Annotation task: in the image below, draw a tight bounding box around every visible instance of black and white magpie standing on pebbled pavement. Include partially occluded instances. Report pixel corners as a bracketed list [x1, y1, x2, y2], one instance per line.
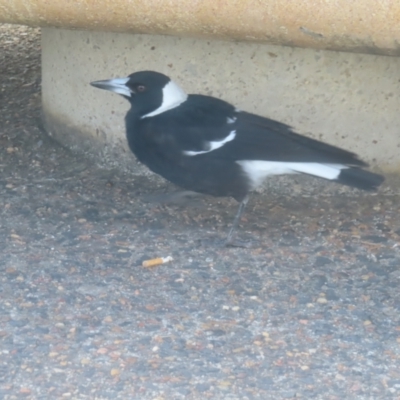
[90, 71, 384, 246]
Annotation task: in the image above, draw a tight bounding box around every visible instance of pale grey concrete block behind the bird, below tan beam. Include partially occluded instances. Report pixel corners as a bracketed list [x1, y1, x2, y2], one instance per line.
[42, 28, 400, 173]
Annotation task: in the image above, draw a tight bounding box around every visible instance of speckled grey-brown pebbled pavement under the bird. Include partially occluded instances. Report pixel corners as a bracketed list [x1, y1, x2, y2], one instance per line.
[0, 25, 400, 400]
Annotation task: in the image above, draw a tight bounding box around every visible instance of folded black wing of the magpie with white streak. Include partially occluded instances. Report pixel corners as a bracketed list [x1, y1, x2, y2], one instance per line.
[142, 95, 366, 167]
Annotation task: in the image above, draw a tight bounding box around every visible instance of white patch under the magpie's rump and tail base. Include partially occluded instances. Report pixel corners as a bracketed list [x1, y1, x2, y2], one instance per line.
[236, 160, 348, 189]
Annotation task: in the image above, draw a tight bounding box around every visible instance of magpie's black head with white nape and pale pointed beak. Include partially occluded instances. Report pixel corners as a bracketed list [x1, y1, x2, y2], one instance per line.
[90, 71, 187, 118]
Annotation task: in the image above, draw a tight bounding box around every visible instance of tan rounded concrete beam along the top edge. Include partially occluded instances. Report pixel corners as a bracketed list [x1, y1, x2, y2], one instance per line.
[0, 0, 400, 55]
